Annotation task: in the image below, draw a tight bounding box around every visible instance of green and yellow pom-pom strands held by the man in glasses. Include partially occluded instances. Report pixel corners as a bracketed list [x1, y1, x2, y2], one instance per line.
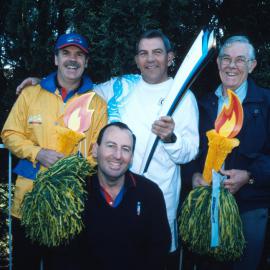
[179, 187, 245, 261]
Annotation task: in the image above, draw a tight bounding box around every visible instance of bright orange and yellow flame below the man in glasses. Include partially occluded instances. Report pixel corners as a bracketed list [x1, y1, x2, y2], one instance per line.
[215, 89, 243, 138]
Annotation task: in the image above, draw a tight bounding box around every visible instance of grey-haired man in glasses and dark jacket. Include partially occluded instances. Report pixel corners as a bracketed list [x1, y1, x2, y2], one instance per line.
[184, 36, 270, 270]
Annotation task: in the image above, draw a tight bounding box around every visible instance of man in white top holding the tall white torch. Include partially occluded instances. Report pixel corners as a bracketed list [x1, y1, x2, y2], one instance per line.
[15, 30, 199, 269]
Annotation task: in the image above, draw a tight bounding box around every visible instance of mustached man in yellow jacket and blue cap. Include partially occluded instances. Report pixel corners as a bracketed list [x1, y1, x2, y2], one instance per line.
[1, 33, 107, 269]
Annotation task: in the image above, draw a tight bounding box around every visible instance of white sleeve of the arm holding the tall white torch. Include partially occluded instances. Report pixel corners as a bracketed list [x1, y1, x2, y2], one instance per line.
[163, 91, 199, 164]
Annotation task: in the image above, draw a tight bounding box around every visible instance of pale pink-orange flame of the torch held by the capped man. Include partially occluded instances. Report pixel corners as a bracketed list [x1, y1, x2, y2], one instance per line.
[64, 92, 95, 132]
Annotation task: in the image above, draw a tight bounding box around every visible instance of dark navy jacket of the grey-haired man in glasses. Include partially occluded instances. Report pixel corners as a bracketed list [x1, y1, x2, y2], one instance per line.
[182, 79, 270, 211]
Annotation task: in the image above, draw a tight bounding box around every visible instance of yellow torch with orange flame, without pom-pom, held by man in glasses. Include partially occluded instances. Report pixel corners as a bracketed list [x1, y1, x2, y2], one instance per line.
[203, 90, 243, 184]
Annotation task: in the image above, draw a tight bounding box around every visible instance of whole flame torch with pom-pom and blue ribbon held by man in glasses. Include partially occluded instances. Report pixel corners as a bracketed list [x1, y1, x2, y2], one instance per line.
[179, 90, 245, 261]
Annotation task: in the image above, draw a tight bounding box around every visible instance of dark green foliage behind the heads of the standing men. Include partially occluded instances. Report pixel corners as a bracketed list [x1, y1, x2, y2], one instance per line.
[0, 0, 270, 99]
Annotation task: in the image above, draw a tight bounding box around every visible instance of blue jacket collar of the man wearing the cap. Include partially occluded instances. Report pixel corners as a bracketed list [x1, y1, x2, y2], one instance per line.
[40, 72, 93, 94]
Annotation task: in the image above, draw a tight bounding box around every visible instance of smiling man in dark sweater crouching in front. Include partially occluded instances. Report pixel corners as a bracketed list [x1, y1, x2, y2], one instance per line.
[80, 122, 171, 270]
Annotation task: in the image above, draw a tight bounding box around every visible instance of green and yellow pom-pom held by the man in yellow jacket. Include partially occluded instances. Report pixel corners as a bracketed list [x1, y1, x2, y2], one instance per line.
[21, 155, 94, 246]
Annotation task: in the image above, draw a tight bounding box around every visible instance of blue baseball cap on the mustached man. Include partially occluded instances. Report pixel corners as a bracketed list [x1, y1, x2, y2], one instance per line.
[54, 33, 89, 54]
